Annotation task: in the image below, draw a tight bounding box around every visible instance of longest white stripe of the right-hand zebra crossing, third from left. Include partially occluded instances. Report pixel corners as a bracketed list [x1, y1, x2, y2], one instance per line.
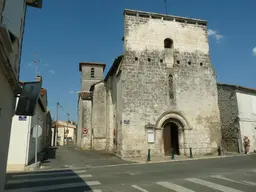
[185, 178, 243, 192]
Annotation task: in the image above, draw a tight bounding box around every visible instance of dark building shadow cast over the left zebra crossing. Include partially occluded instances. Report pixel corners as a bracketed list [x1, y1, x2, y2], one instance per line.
[5, 169, 94, 192]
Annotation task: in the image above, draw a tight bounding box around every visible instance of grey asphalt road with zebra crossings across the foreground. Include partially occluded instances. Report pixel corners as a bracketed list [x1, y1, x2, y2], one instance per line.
[3, 152, 256, 192]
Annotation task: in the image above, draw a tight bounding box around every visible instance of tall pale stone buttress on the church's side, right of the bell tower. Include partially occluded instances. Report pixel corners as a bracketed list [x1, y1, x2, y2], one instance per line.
[92, 83, 107, 150]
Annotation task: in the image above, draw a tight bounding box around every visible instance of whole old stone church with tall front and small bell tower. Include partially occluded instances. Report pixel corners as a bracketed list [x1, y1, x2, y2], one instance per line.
[77, 10, 221, 157]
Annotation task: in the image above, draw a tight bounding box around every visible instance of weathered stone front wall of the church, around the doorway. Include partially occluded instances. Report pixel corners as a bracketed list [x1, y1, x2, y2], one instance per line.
[121, 11, 221, 156]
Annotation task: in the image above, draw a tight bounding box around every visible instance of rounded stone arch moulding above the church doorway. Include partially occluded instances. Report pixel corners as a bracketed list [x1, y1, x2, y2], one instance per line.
[156, 111, 192, 130]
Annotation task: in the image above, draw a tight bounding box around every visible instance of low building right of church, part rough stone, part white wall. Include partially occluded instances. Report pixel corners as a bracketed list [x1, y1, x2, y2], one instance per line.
[218, 83, 256, 153]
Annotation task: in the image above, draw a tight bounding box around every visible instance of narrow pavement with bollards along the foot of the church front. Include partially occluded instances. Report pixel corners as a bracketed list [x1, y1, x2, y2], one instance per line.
[121, 153, 256, 164]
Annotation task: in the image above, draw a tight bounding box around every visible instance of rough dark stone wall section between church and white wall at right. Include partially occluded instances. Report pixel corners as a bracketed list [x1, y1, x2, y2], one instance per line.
[218, 85, 239, 152]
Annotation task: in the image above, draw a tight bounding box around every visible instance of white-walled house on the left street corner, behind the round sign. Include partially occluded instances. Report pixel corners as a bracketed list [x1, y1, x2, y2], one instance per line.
[7, 79, 51, 171]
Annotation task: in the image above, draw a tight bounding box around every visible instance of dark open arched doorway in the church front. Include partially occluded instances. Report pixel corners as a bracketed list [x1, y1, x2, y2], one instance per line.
[163, 122, 180, 155]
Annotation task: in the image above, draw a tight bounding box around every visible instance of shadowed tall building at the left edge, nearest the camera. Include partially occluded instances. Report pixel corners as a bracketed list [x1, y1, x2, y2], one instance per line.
[0, 0, 42, 191]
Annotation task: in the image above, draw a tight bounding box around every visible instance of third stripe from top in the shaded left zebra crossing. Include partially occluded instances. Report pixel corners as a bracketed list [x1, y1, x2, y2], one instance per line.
[5, 181, 101, 192]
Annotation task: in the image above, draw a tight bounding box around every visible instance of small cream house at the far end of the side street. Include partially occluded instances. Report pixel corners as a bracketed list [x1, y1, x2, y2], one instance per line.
[52, 121, 76, 146]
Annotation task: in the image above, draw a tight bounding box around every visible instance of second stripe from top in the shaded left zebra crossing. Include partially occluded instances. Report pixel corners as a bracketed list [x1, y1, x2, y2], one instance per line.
[7, 175, 92, 184]
